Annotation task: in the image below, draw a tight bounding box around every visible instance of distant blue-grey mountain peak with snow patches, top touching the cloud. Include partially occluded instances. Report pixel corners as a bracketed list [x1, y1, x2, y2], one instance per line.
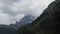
[15, 15, 35, 27]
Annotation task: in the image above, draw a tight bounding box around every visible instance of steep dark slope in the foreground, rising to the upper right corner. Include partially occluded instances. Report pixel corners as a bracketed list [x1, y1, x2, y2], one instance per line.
[17, 0, 60, 34]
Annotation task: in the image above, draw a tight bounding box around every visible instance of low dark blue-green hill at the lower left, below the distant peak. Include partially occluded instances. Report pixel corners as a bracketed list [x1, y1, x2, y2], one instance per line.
[0, 25, 17, 34]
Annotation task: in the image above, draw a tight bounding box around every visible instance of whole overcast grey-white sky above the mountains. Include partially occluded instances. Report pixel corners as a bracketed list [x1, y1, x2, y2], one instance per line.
[0, 0, 54, 24]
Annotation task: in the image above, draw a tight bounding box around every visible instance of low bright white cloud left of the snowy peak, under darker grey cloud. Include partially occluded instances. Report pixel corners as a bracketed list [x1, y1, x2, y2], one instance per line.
[0, 11, 24, 25]
